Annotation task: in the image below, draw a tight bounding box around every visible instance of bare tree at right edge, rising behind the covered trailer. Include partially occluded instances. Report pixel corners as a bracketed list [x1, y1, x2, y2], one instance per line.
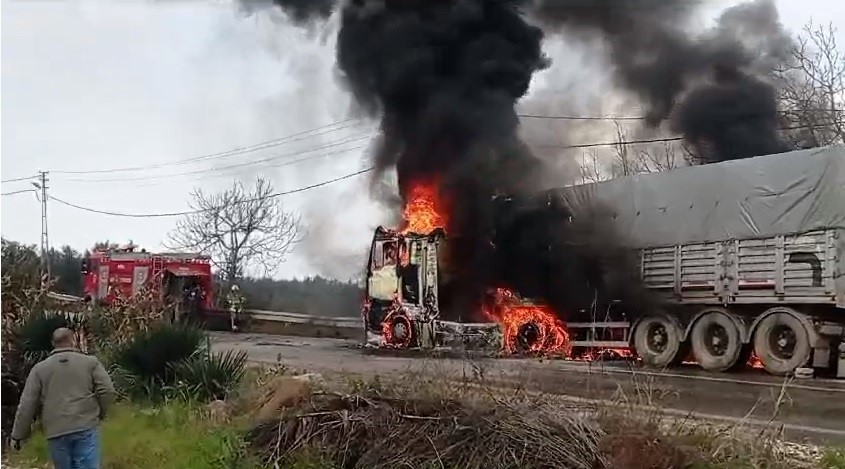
[775, 22, 845, 147]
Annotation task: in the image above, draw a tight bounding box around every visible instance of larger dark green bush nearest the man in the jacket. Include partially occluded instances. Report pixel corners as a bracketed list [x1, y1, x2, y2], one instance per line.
[112, 323, 205, 400]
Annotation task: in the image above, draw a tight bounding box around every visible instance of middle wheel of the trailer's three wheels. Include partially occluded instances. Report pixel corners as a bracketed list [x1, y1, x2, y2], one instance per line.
[690, 310, 742, 371]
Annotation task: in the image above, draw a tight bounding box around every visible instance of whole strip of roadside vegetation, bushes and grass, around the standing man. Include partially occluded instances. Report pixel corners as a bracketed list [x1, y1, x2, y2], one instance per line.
[2, 239, 845, 469]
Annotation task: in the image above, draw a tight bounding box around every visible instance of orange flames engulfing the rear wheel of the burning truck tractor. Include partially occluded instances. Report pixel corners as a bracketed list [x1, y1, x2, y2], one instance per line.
[482, 288, 570, 355]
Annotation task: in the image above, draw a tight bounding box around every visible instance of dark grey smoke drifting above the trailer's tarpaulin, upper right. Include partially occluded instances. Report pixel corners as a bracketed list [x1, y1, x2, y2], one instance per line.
[532, 0, 792, 162]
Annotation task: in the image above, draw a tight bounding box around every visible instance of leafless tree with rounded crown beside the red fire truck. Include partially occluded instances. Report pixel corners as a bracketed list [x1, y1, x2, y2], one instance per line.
[167, 178, 300, 284]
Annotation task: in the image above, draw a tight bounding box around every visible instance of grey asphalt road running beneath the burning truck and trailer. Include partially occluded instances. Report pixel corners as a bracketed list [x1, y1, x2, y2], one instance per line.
[212, 333, 845, 445]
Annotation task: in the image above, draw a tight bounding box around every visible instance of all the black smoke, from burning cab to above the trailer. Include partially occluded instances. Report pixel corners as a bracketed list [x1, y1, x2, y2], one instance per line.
[252, 0, 790, 317]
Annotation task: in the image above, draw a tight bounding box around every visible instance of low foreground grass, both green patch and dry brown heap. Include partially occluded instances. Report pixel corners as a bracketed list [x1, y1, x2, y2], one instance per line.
[3, 366, 845, 469]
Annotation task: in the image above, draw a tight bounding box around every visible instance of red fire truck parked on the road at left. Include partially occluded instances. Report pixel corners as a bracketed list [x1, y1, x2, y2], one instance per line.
[82, 244, 213, 310]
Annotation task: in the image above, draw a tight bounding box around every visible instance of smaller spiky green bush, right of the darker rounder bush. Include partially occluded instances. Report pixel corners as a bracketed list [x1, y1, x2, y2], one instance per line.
[175, 350, 247, 401]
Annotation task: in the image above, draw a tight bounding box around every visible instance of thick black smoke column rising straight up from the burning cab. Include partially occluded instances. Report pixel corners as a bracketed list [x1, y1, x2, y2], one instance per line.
[337, 0, 548, 317]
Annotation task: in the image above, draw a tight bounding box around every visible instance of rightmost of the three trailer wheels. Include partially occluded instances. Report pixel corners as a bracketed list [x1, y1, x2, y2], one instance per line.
[754, 312, 812, 375]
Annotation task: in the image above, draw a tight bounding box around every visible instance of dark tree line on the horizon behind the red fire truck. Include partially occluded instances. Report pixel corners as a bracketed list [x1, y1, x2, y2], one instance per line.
[2, 239, 362, 316]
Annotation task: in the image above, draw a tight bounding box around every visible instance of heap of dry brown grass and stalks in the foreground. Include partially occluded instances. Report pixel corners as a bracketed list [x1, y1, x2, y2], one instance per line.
[239, 362, 820, 469]
